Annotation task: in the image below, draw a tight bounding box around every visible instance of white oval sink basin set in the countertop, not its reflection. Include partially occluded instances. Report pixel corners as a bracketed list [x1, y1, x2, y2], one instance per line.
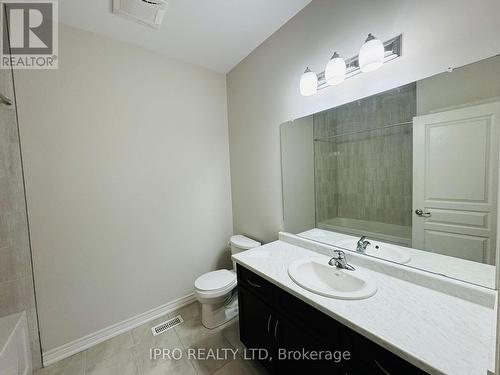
[288, 258, 377, 299]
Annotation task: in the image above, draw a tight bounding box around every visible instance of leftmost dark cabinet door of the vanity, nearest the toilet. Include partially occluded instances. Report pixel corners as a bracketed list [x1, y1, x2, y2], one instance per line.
[238, 286, 275, 372]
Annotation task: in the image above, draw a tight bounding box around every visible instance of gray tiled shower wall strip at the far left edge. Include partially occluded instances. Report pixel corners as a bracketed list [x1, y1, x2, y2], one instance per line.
[0, 69, 41, 368]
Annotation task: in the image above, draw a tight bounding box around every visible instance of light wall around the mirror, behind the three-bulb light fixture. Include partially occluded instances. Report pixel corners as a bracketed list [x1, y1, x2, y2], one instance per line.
[227, 0, 500, 241]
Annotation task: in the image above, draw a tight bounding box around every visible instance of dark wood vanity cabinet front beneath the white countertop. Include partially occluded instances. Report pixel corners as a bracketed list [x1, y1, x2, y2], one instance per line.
[237, 265, 425, 375]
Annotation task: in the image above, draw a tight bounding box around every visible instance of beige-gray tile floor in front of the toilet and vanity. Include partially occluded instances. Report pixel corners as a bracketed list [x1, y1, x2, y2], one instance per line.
[35, 302, 267, 375]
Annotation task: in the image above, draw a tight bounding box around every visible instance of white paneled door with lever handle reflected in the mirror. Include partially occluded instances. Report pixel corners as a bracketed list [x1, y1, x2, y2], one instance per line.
[412, 102, 500, 264]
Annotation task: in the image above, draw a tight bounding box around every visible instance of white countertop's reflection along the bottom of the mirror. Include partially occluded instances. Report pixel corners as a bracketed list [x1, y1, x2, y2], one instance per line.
[298, 228, 495, 289]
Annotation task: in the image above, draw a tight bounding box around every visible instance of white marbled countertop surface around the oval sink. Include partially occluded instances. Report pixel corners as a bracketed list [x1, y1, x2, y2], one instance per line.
[233, 241, 496, 375]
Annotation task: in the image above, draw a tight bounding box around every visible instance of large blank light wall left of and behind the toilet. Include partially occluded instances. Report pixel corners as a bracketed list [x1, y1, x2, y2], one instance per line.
[15, 26, 232, 351]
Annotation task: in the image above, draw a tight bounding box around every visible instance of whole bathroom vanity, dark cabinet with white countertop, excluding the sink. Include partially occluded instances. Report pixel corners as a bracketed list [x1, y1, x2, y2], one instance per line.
[233, 234, 495, 375]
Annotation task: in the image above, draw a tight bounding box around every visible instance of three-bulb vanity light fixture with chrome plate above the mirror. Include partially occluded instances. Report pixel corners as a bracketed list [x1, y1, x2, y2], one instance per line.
[300, 34, 403, 96]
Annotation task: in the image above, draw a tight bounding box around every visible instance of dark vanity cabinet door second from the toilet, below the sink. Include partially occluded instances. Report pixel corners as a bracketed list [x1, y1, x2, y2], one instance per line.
[272, 316, 346, 375]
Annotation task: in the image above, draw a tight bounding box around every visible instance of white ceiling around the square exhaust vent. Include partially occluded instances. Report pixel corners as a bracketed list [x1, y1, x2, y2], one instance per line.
[59, 0, 311, 73]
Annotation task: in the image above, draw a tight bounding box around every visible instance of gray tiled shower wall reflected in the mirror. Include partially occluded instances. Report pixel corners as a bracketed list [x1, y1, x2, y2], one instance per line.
[313, 83, 416, 226]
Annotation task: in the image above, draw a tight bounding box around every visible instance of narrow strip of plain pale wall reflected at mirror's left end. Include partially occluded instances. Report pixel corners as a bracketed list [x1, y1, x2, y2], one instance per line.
[280, 116, 316, 233]
